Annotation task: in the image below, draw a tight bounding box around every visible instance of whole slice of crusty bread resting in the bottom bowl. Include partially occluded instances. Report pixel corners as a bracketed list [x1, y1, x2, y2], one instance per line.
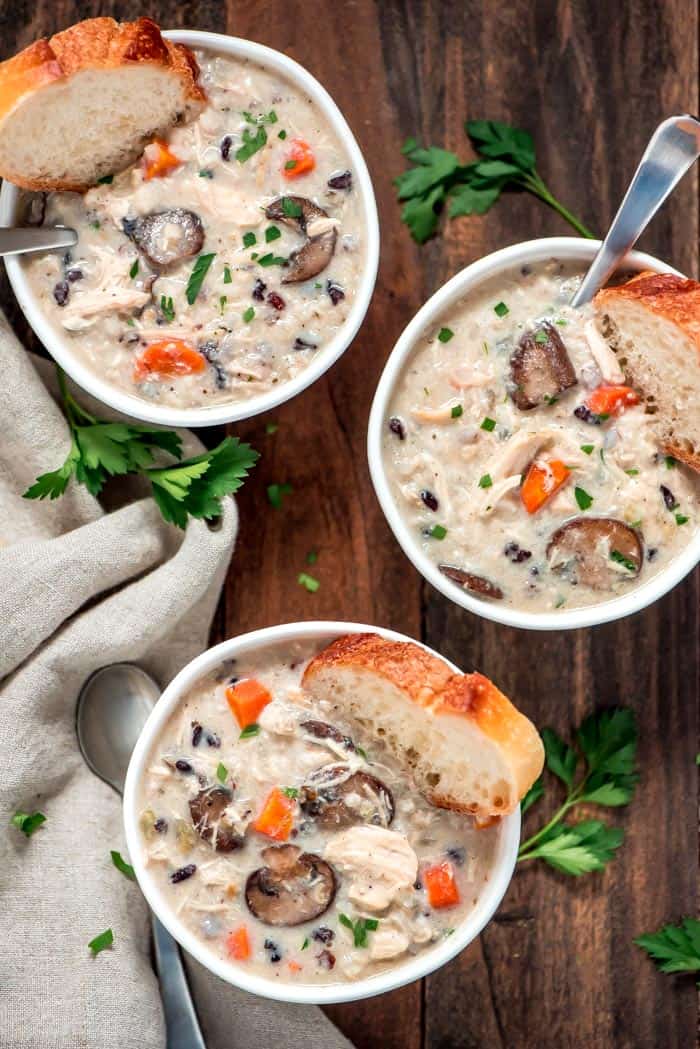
[302, 634, 544, 818]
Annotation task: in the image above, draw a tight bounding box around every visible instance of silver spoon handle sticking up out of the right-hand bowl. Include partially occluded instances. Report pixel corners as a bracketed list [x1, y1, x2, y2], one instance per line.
[571, 115, 700, 306]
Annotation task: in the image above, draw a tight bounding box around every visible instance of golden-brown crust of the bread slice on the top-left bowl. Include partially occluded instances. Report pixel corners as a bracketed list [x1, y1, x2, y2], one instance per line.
[0, 18, 207, 192]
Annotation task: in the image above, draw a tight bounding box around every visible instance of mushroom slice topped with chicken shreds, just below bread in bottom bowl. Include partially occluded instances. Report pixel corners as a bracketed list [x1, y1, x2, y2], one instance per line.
[299, 765, 394, 827]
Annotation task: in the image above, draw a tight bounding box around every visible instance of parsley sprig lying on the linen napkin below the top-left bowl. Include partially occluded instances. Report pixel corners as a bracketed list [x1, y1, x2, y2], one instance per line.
[24, 368, 259, 528]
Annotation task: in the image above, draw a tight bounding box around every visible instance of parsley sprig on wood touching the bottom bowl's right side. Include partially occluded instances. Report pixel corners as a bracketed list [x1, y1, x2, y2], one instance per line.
[517, 709, 638, 876]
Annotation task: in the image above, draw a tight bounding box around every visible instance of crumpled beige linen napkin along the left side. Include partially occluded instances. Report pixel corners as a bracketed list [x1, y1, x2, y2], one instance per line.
[0, 315, 349, 1049]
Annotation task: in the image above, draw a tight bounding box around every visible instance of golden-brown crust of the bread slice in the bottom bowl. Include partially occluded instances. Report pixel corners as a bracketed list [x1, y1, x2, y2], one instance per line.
[302, 634, 544, 815]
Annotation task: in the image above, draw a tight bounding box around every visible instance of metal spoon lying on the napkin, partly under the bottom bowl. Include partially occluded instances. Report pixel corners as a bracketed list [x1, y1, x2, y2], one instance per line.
[76, 663, 206, 1049]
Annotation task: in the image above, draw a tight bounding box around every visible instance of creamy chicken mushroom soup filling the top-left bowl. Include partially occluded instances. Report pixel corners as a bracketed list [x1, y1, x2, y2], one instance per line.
[23, 52, 365, 408]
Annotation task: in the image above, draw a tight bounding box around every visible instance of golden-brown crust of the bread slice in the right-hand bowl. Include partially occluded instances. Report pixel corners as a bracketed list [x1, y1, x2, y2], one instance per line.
[594, 270, 700, 472]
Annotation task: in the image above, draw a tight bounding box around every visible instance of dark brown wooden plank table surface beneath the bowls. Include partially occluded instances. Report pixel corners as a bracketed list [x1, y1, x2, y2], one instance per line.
[0, 0, 700, 1049]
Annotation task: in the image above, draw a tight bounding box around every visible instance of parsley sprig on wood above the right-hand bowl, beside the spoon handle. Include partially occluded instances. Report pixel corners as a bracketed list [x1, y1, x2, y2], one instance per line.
[395, 121, 593, 244]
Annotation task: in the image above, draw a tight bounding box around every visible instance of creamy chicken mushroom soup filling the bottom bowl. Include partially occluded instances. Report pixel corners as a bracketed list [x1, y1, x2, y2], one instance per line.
[141, 644, 499, 983]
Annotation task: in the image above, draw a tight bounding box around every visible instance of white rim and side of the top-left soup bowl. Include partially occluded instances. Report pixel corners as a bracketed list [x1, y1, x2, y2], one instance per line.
[0, 29, 379, 427]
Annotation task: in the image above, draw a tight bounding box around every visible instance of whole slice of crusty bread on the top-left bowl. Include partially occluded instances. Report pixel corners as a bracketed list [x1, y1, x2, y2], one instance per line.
[0, 18, 206, 191]
